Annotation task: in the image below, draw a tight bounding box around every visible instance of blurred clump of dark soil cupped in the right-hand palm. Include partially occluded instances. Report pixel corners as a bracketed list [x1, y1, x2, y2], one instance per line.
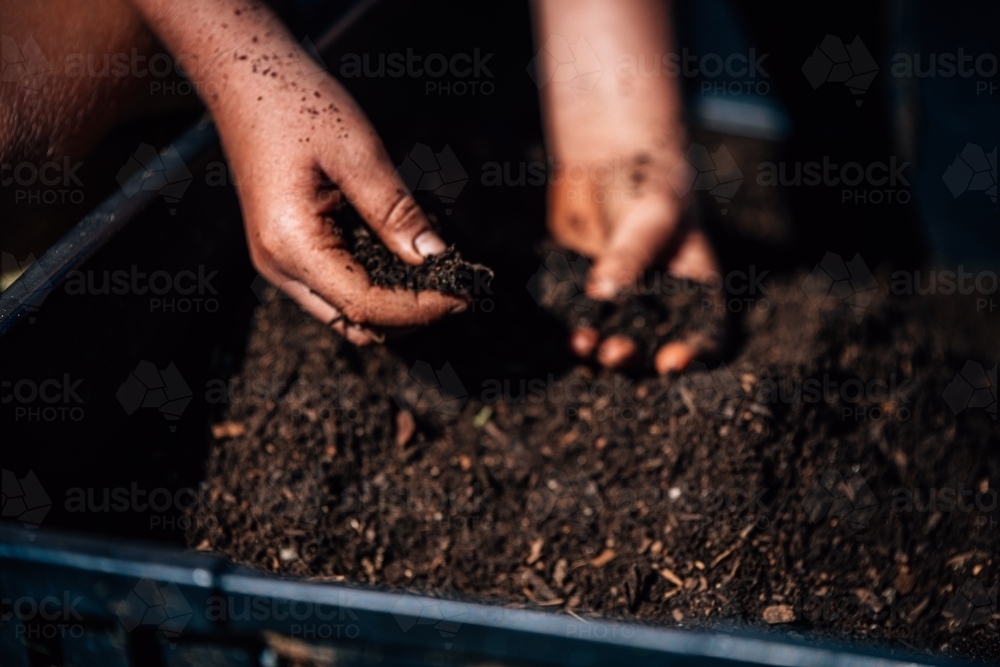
[528, 244, 726, 368]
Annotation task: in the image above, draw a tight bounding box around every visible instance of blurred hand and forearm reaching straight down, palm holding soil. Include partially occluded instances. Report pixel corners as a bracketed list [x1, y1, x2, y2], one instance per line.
[536, 0, 722, 373]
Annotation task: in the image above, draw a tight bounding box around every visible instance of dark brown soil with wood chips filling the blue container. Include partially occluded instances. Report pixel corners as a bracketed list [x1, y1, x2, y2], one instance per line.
[188, 241, 1000, 660]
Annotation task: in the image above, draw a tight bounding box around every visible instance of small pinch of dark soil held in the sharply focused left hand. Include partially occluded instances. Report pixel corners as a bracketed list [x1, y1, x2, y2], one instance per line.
[344, 224, 493, 296]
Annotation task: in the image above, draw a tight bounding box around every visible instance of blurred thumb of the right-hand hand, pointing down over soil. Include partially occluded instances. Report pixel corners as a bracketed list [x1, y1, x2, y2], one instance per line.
[587, 194, 680, 300]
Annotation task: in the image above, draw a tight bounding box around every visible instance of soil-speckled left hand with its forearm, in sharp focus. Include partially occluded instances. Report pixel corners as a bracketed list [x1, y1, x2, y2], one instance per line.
[128, 0, 465, 345]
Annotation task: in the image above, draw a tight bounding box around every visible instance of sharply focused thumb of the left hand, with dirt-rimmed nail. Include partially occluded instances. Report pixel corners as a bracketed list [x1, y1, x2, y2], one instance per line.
[321, 133, 447, 265]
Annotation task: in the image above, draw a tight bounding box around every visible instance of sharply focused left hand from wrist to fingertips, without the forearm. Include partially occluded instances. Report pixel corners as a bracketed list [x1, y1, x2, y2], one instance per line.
[218, 56, 465, 345]
